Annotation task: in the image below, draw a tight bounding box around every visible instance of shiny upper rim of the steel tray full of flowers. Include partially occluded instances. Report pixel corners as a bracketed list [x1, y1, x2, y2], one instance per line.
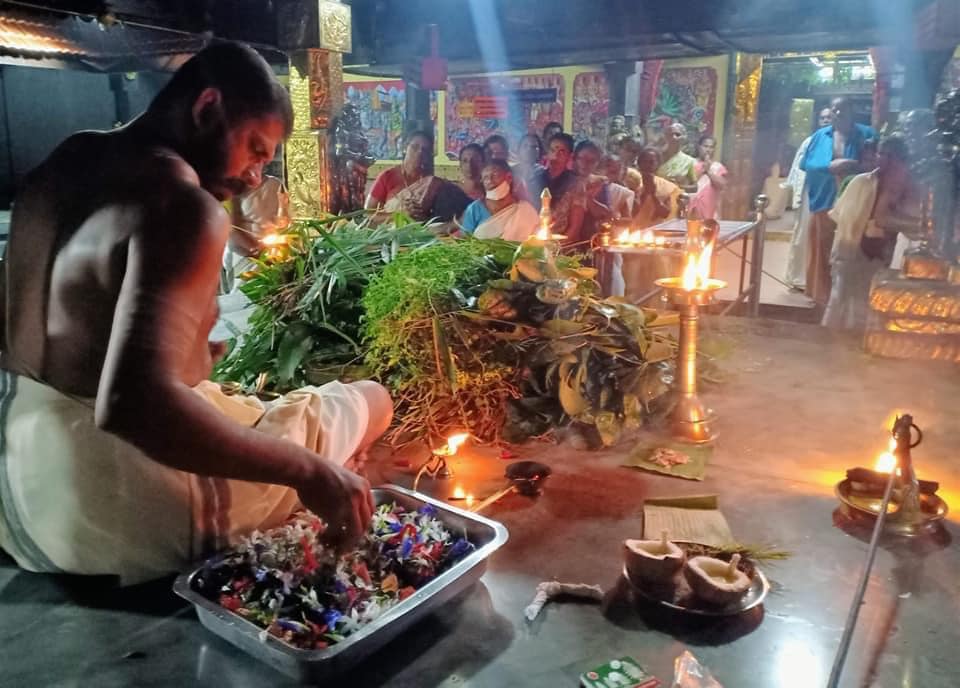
[173, 484, 510, 664]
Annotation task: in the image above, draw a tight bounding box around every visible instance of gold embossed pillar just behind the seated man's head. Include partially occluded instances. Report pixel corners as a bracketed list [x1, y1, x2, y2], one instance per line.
[277, 0, 352, 218]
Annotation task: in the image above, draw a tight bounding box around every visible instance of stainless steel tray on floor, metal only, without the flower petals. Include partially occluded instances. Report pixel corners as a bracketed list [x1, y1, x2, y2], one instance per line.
[173, 485, 508, 683]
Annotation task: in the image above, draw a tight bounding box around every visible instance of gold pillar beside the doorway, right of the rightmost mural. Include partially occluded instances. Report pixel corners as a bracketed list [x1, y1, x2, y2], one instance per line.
[723, 53, 763, 218]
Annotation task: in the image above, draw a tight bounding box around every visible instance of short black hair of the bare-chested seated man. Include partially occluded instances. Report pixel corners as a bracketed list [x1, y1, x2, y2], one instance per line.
[150, 42, 293, 136]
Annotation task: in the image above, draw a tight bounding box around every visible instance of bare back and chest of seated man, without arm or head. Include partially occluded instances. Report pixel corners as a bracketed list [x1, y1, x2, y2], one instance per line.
[5, 130, 219, 398]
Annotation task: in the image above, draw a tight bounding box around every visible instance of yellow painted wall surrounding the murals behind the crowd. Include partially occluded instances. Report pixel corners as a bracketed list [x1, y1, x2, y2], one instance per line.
[343, 55, 729, 177]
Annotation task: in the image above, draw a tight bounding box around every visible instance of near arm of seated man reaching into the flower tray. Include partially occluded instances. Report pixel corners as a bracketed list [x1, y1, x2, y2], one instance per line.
[96, 184, 373, 537]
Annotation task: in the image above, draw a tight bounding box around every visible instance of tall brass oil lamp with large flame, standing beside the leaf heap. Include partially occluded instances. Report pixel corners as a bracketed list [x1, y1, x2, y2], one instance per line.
[656, 222, 727, 444]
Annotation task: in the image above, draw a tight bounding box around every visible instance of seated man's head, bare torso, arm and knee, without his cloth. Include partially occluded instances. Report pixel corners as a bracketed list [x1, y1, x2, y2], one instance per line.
[4, 44, 382, 564]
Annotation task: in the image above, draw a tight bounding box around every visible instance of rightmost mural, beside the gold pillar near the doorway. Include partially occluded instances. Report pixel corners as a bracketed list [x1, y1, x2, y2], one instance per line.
[647, 67, 717, 154]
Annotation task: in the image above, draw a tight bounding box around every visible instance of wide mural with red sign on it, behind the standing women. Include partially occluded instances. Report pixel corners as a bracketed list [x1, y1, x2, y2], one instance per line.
[444, 74, 564, 158]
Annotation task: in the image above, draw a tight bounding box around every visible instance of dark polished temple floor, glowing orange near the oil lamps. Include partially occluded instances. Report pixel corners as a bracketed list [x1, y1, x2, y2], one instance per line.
[0, 318, 960, 688]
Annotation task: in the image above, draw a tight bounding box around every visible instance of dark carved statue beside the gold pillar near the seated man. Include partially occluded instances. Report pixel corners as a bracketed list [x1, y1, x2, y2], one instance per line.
[330, 103, 376, 215]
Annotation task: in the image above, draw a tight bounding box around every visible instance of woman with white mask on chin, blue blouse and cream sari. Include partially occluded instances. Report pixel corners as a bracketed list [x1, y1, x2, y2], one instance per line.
[460, 160, 540, 241]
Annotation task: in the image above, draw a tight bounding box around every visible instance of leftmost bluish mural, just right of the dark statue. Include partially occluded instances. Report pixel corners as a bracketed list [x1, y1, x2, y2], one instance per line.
[344, 80, 406, 160]
